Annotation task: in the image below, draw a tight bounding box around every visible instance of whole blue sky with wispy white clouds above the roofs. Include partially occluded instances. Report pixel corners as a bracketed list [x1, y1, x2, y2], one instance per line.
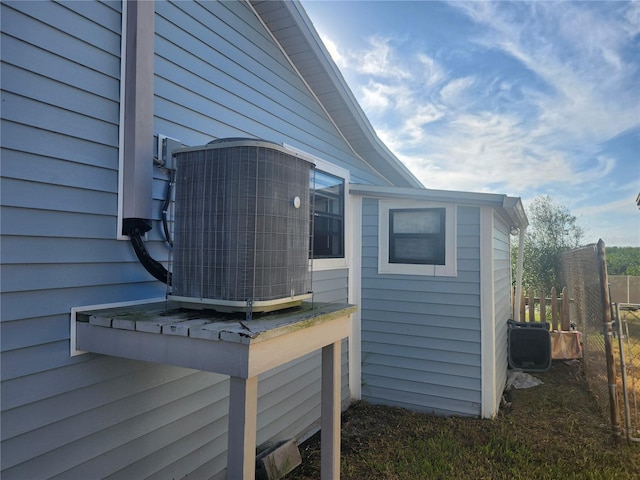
[302, 0, 640, 246]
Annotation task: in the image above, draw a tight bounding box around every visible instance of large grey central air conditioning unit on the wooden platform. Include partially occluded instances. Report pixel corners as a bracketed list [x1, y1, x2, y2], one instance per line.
[168, 139, 313, 312]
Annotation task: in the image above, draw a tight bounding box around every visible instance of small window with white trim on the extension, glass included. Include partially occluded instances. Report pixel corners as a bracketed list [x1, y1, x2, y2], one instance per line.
[378, 200, 456, 276]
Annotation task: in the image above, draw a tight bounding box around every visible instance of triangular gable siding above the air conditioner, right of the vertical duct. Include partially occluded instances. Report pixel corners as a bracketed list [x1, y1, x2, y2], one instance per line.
[154, 1, 380, 183]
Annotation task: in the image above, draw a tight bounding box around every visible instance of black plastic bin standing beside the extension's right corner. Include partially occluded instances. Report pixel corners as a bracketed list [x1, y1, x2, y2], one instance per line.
[507, 320, 551, 372]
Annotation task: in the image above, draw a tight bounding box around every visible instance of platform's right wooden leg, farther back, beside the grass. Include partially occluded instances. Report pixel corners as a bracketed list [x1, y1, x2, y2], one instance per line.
[320, 341, 341, 480]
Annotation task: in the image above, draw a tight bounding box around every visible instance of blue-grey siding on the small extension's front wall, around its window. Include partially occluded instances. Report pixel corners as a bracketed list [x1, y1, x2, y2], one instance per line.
[362, 198, 481, 415]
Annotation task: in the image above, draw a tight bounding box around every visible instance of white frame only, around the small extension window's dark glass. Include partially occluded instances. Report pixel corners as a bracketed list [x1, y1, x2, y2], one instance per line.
[378, 200, 458, 277]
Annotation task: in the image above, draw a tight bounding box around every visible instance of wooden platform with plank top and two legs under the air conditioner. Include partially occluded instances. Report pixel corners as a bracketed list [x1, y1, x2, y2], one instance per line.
[75, 301, 357, 480]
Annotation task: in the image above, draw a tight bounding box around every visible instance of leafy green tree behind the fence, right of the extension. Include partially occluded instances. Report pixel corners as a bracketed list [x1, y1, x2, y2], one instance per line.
[512, 195, 584, 292]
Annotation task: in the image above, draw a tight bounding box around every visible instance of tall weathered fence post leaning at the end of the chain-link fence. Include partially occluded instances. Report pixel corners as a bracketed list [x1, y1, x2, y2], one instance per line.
[598, 239, 620, 441]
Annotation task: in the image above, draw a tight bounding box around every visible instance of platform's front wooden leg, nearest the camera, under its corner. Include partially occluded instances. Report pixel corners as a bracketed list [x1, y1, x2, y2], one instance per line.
[227, 376, 258, 480]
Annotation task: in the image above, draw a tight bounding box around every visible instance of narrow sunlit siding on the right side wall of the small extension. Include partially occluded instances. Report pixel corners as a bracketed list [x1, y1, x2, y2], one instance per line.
[493, 214, 511, 404]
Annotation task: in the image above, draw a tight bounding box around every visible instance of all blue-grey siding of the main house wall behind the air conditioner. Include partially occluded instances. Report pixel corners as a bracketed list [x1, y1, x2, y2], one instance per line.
[0, 2, 352, 480]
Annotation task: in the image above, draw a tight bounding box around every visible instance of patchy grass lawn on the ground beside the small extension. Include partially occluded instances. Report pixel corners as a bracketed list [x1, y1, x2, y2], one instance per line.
[287, 361, 640, 480]
